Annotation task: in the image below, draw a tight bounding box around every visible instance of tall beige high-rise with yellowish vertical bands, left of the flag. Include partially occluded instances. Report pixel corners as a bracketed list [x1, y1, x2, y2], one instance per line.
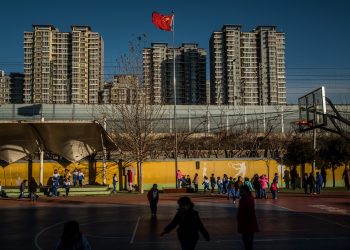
[24, 25, 104, 103]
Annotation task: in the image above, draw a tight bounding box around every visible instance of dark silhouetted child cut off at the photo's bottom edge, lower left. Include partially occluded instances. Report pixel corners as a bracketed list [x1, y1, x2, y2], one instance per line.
[55, 220, 91, 250]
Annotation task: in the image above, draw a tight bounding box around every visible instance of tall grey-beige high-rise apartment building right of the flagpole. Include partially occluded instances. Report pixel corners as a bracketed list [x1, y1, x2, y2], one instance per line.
[209, 25, 286, 105]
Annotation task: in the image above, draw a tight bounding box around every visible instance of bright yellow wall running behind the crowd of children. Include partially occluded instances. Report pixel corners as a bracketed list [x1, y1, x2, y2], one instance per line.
[0, 159, 344, 190]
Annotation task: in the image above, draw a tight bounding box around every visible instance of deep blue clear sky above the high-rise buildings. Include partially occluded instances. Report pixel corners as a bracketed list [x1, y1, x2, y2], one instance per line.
[0, 0, 350, 103]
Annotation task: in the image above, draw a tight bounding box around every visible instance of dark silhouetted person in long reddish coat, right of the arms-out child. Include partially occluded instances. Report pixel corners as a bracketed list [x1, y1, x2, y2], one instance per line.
[236, 185, 259, 250]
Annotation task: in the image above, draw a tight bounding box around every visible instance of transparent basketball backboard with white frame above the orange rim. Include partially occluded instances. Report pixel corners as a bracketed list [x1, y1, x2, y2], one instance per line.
[298, 86, 327, 131]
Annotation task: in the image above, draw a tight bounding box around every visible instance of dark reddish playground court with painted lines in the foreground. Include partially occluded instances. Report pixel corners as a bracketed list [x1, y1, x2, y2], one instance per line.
[0, 191, 350, 250]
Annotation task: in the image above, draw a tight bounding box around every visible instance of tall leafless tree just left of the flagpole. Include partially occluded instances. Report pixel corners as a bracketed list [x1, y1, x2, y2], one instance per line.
[97, 35, 164, 193]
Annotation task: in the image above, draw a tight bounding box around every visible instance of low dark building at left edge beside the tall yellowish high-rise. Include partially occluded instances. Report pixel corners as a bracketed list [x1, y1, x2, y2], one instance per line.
[0, 70, 24, 103]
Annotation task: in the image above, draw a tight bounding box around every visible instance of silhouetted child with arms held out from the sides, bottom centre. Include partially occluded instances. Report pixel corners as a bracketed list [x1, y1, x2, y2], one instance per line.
[160, 196, 210, 250]
